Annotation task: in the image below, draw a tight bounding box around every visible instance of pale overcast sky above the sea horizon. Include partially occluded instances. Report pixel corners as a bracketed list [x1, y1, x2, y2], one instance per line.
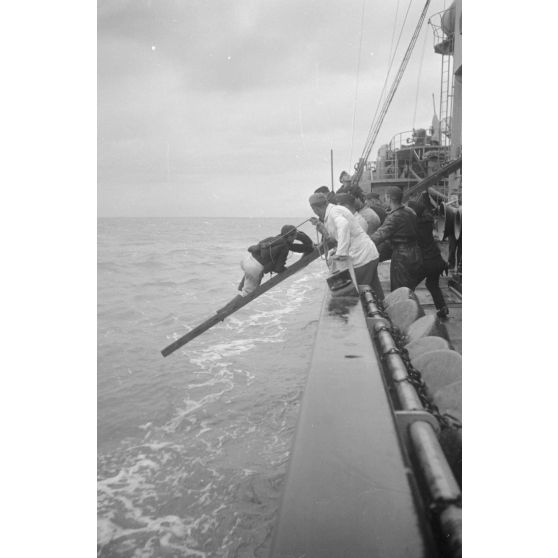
[97, 0, 450, 217]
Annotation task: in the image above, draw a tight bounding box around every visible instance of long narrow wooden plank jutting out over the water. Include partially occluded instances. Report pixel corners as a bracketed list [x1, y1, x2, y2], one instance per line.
[161, 246, 323, 357]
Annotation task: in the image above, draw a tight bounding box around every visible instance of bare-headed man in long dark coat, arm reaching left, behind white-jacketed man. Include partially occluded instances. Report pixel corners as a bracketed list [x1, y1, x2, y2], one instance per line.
[370, 186, 422, 291]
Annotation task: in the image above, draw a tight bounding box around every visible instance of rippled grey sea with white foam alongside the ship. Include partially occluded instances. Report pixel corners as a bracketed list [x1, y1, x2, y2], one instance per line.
[97, 218, 325, 558]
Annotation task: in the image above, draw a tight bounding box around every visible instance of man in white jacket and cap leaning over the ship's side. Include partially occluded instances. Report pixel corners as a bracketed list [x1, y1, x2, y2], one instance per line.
[309, 194, 384, 301]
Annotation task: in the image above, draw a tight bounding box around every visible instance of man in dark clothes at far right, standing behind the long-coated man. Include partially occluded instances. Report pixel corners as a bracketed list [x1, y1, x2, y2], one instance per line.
[407, 201, 449, 319]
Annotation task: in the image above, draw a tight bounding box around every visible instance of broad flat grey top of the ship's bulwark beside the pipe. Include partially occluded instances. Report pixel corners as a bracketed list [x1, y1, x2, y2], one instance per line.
[271, 293, 437, 558]
